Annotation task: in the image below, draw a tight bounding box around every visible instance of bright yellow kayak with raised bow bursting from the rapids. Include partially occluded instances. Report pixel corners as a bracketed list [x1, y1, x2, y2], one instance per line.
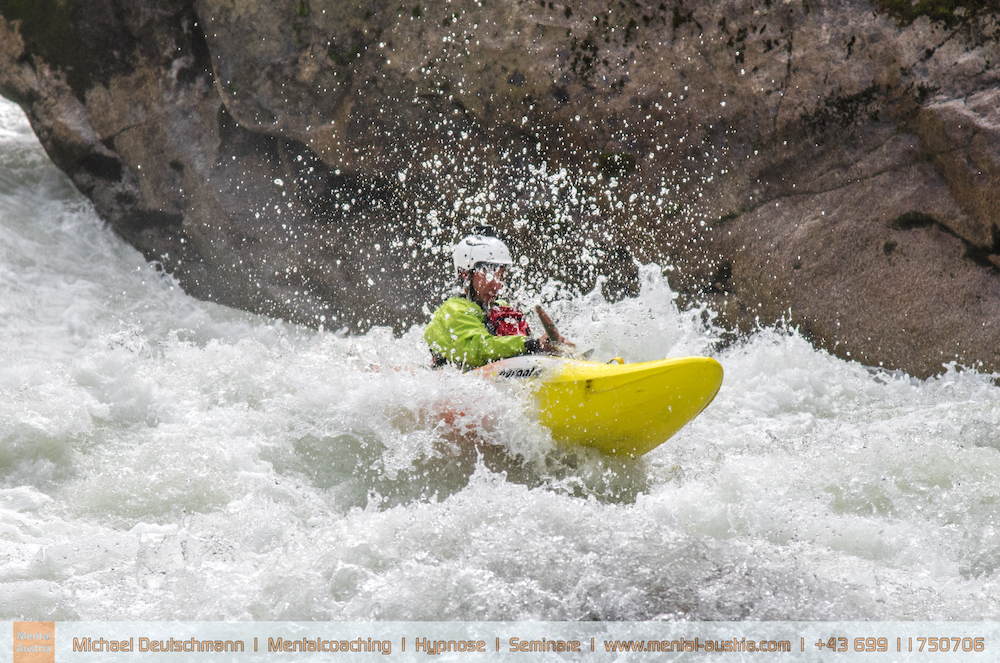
[476, 355, 722, 457]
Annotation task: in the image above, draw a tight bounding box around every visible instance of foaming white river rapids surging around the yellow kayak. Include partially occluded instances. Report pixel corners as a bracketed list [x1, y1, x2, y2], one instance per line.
[0, 96, 1000, 621]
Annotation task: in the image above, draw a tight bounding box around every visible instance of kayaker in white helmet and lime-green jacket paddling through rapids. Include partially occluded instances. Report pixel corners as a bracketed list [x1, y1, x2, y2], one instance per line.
[424, 226, 566, 368]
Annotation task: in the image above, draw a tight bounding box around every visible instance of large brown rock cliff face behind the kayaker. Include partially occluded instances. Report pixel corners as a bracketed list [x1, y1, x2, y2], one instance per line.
[0, 0, 1000, 376]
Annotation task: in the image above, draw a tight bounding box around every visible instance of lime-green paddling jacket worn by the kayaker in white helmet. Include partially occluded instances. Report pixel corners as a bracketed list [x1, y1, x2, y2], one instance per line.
[424, 297, 526, 368]
